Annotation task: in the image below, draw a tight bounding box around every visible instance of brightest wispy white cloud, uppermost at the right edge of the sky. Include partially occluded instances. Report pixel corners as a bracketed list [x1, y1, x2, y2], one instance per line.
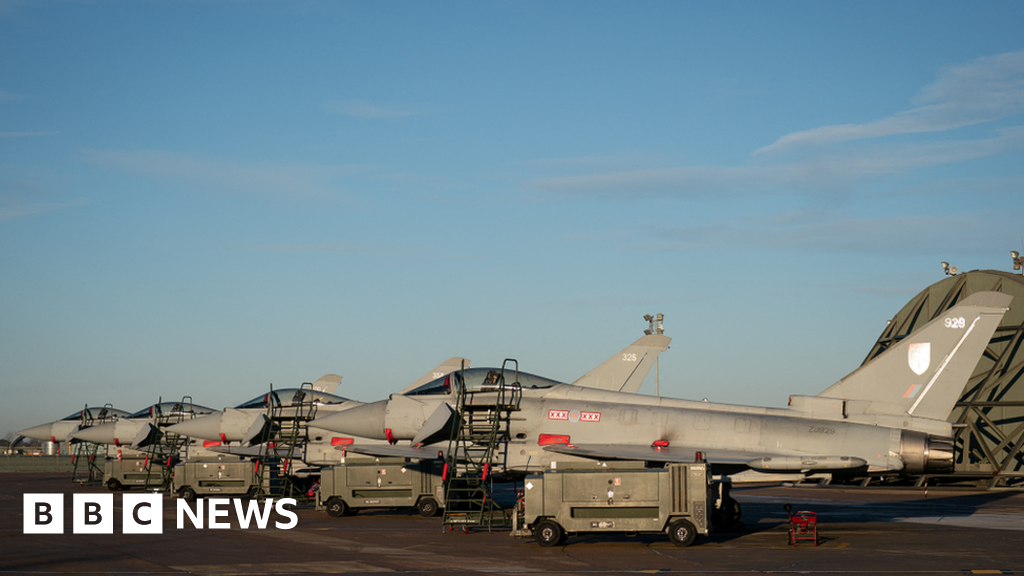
[754, 50, 1024, 155]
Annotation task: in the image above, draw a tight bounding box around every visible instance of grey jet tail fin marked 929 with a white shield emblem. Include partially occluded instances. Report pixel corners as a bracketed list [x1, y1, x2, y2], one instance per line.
[818, 292, 1013, 420]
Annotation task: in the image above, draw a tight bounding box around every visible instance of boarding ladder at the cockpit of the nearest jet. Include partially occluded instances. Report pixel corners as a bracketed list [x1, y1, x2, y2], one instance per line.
[443, 359, 522, 531]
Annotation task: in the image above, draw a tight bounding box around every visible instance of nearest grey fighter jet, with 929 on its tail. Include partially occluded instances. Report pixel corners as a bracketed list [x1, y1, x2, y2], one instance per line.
[312, 292, 1012, 482]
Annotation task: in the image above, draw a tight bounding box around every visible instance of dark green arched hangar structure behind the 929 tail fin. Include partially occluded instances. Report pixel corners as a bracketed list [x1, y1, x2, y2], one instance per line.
[864, 262, 1024, 488]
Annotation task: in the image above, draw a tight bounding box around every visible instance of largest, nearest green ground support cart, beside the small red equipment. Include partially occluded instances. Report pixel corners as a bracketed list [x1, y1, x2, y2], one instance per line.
[513, 462, 713, 546]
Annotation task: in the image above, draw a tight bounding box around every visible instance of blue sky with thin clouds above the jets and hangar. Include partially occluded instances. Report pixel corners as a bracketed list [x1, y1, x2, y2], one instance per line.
[0, 0, 1024, 434]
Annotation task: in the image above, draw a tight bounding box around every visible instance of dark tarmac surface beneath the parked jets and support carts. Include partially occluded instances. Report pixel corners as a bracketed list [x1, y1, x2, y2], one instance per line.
[0, 472, 1024, 575]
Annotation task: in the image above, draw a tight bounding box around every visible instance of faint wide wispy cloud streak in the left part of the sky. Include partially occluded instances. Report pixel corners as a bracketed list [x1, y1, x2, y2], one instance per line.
[85, 150, 358, 197]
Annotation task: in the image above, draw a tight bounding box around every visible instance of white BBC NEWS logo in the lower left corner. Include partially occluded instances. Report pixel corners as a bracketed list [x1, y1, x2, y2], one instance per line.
[22, 494, 299, 534]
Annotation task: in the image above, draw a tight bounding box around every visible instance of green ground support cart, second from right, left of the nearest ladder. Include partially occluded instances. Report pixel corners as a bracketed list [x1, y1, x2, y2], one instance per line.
[316, 458, 444, 518]
